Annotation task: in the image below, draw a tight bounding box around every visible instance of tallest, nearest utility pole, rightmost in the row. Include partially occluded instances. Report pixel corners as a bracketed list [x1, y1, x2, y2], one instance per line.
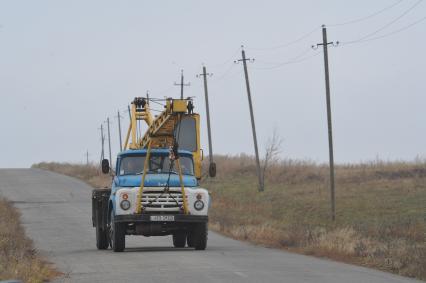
[312, 25, 339, 221]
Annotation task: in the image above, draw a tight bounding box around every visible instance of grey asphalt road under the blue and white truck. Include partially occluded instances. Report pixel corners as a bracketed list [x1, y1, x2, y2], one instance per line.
[0, 169, 418, 283]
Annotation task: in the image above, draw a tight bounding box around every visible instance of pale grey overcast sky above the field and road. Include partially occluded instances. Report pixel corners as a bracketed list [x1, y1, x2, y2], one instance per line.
[0, 0, 426, 167]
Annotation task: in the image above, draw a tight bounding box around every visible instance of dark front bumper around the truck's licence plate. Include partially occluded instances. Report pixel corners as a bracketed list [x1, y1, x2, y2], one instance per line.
[114, 214, 209, 223]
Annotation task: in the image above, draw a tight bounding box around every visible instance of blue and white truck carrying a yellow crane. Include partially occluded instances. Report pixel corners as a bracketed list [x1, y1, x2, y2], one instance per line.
[92, 97, 215, 252]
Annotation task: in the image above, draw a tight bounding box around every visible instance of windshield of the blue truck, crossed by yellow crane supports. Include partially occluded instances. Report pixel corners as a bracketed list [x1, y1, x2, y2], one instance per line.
[119, 155, 194, 176]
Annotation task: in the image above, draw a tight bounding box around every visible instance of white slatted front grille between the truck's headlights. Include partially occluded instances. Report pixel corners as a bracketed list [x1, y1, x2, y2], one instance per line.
[141, 187, 183, 212]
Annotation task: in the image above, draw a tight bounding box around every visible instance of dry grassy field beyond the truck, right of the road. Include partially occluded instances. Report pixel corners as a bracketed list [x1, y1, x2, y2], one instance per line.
[35, 156, 426, 280]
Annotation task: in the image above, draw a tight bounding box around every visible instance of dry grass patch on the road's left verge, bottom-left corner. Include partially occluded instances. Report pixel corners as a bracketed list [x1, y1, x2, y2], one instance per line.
[0, 199, 59, 282]
